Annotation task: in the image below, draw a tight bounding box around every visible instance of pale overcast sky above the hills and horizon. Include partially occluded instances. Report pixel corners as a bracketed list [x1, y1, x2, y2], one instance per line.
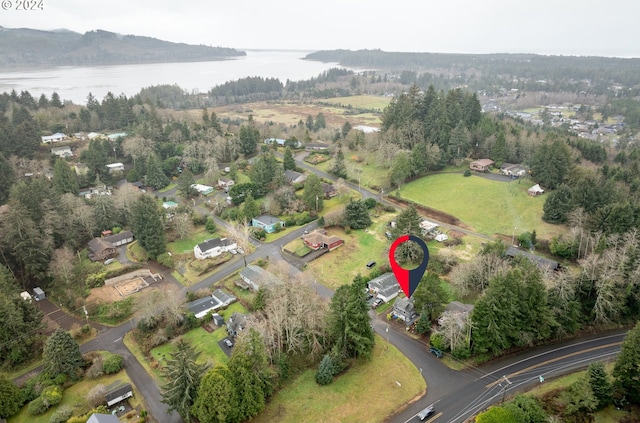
[0, 0, 640, 57]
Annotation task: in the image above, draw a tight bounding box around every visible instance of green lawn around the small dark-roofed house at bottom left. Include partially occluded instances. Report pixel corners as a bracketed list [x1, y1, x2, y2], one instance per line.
[7, 370, 142, 423]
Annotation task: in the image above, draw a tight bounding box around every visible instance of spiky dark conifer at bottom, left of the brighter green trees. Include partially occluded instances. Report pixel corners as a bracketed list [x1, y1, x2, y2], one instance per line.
[162, 338, 209, 423]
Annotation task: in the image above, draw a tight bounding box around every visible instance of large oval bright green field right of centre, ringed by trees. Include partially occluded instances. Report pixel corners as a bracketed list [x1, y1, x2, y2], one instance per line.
[394, 174, 564, 239]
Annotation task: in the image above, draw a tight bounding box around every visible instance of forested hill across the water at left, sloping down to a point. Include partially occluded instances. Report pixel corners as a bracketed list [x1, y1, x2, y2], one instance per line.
[0, 27, 246, 69]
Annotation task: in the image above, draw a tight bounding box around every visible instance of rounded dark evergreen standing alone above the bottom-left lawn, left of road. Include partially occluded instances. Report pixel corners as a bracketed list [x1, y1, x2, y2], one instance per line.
[42, 328, 84, 380]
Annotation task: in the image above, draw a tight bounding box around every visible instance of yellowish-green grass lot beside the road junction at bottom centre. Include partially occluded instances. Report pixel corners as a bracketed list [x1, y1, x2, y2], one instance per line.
[251, 336, 426, 423]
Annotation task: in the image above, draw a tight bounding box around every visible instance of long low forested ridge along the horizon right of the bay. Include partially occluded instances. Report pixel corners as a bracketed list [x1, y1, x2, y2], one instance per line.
[305, 50, 640, 87]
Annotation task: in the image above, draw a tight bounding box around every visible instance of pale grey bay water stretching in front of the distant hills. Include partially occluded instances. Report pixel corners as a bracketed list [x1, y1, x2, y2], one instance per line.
[0, 50, 338, 104]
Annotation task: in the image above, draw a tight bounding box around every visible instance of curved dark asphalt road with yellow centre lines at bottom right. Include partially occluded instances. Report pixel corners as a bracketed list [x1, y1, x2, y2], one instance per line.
[388, 331, 626, 423]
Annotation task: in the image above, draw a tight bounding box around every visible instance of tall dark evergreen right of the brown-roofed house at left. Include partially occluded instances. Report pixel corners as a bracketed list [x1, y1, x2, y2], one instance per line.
[131, 195, 166, 260]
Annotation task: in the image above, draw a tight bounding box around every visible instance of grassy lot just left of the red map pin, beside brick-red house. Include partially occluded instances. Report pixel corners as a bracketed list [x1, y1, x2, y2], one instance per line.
[300, 213, 394, 289]
